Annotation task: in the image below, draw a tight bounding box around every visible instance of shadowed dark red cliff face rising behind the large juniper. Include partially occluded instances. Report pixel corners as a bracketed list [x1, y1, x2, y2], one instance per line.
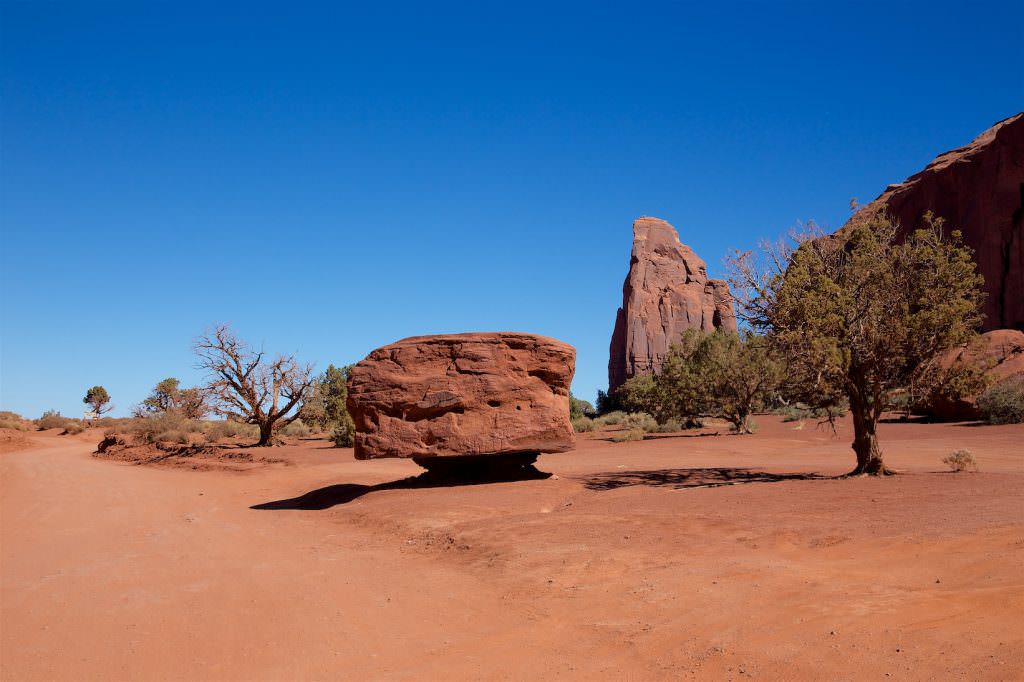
[850, 114, 1024, 331]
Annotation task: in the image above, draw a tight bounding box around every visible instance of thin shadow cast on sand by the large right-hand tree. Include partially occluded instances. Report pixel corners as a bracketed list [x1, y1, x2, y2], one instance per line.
[580, 467, 834, 491]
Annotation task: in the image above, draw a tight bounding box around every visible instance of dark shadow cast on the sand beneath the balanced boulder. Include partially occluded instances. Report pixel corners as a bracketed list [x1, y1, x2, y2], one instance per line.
[250, 466, 551, 511]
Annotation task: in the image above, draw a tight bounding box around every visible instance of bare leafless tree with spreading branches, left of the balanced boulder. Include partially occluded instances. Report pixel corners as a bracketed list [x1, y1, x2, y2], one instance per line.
[193, 325, 315, 445]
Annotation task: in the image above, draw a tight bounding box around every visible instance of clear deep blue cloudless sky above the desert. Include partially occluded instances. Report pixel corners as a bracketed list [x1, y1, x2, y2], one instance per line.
[0, 0, 1024, 417]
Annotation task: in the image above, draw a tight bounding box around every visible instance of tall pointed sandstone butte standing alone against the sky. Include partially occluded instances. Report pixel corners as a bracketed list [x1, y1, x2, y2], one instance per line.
[608, 217, 736, 393]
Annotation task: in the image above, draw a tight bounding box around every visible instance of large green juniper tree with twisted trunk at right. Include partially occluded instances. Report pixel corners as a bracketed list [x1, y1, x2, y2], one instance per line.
[729, 214, 982, 475]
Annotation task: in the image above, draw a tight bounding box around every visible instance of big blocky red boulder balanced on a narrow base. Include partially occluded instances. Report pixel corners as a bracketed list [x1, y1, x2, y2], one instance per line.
[348, 332, 575, 460]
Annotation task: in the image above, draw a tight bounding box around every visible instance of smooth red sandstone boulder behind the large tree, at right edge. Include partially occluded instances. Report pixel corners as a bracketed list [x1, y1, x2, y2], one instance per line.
[928, 329, 1024, 421]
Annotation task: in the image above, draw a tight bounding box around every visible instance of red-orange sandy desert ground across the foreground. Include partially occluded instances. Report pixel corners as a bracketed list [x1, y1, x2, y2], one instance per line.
[0, 417, 1024, 680]
